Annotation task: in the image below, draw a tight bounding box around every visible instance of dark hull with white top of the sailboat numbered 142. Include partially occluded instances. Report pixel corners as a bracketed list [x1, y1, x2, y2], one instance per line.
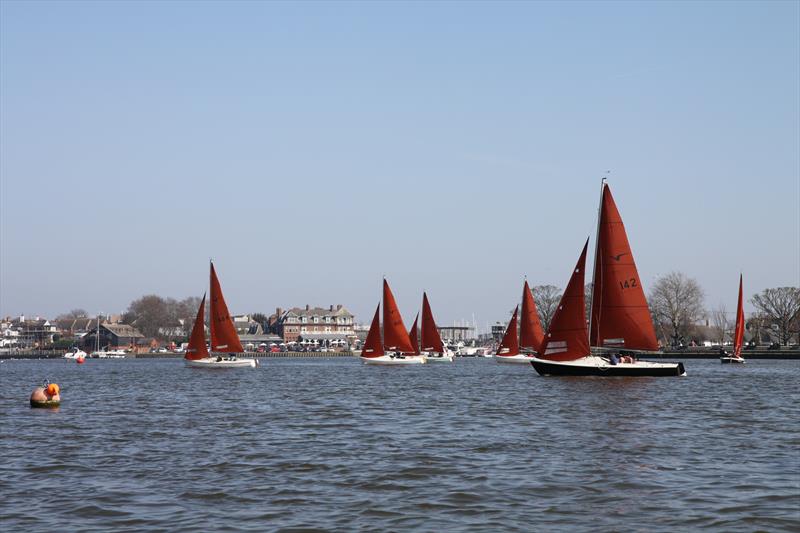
[531, 356, 686, 377]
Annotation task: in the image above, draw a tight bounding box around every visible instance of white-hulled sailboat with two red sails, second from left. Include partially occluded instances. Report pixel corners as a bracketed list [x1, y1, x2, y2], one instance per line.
[360, 279, 426, 365]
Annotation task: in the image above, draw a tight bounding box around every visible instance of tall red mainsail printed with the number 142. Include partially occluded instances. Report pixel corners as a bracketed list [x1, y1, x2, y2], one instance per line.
[590, 183, 658, 350]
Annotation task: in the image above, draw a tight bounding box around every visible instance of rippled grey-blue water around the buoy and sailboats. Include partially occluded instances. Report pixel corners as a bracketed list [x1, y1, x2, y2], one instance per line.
[0, 359, 800, 532]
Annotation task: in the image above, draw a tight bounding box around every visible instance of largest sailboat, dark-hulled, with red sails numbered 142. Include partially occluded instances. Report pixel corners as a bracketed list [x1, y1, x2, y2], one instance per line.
[531, 180, 686, 376]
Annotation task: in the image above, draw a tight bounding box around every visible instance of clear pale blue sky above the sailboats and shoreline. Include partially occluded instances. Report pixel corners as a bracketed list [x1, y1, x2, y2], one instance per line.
[0, 1, 800, 327]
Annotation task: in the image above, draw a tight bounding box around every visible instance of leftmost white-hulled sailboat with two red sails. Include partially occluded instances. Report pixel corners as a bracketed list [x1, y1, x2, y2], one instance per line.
[184, 263, 256, 368]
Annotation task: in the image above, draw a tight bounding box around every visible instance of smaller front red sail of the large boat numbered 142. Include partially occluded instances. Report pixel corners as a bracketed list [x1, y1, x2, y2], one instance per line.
[541, 239, 591, 361]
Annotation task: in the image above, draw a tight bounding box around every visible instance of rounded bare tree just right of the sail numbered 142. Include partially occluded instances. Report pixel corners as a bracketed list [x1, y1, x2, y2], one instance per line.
[648, 272, 704, 345]
